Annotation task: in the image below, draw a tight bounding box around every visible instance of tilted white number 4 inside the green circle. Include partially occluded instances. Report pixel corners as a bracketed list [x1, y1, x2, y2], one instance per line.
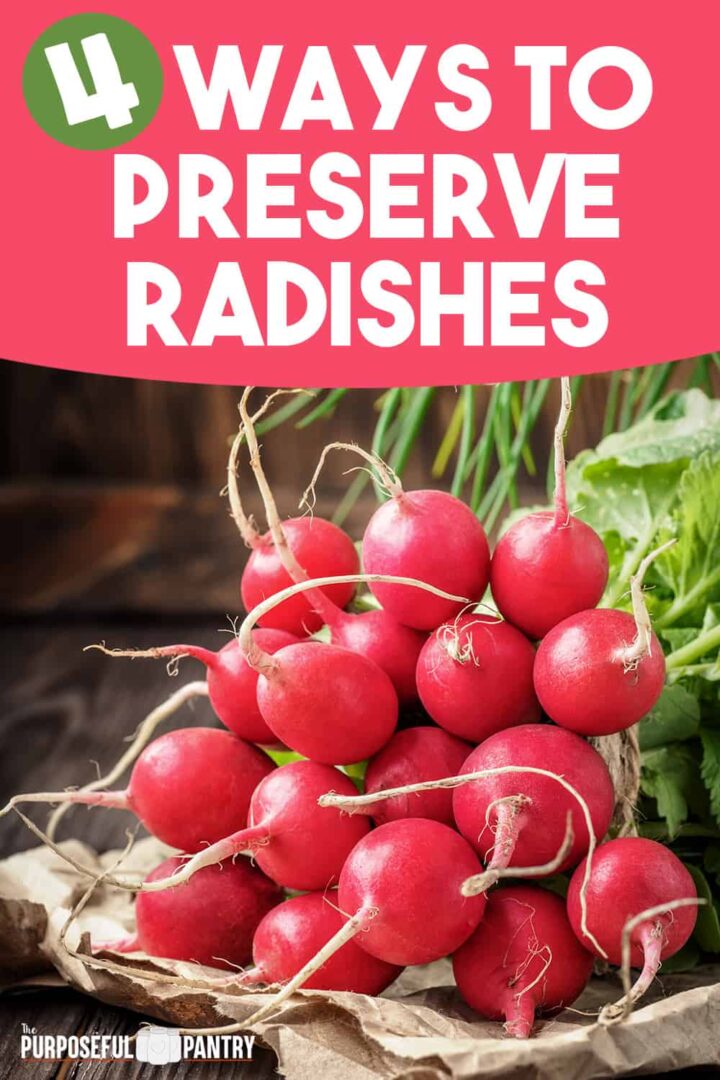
[45, 33, 140, 129]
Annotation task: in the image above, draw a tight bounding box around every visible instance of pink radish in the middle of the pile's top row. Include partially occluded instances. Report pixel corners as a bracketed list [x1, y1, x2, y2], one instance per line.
[363, 490, 490, 630]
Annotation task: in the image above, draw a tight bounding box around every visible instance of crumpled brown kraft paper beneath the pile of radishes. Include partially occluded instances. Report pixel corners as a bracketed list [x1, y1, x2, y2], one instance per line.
[0, 840, 720, 1080]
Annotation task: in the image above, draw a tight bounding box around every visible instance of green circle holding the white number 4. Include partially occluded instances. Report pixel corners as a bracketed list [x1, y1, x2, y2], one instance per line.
[23, 14, 163, 150]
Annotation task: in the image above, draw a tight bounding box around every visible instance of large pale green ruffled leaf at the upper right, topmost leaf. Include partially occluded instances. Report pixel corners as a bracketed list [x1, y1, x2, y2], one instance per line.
[568, 389, 720, 613]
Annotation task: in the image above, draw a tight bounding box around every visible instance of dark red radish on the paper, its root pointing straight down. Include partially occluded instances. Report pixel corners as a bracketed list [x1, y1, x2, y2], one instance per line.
[453, 886, 593, 1039]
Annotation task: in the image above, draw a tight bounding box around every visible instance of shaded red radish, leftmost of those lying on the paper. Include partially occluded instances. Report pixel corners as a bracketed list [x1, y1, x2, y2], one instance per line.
[105, 858, 283, 968]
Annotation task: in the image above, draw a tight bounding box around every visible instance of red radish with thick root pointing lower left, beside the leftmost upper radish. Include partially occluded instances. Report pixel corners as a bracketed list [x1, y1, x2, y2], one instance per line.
[153, 761, 370, 891]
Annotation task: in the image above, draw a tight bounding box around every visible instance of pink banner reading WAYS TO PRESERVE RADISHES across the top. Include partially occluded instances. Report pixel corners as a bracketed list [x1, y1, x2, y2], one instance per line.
[0, 0, 720, 387]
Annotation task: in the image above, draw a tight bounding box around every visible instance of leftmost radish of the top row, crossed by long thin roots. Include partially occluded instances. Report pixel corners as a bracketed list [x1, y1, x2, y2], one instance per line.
[241, 516, 359, 637]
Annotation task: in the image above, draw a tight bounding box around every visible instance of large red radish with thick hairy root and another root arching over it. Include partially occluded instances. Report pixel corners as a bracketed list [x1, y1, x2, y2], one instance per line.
[452, 724, 615, 869]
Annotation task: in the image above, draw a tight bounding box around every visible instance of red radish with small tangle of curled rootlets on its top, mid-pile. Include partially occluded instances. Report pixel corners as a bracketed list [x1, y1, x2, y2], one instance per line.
[417, 615, 540, 743]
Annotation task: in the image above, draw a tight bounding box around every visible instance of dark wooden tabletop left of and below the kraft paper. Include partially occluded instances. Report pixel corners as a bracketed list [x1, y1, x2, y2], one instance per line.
[0, 619, 277, 1080]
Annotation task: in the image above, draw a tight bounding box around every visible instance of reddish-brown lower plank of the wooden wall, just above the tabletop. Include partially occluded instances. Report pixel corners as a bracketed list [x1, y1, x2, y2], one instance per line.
[0, 485, 376, 618]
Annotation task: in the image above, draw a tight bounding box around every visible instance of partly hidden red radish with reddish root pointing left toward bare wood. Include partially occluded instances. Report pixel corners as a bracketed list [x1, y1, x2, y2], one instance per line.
[86, 629, 300, 745]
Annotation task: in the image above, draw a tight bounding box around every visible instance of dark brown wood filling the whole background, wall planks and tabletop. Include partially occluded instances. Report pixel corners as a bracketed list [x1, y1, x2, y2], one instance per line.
[0, 362, 716, 1080]
